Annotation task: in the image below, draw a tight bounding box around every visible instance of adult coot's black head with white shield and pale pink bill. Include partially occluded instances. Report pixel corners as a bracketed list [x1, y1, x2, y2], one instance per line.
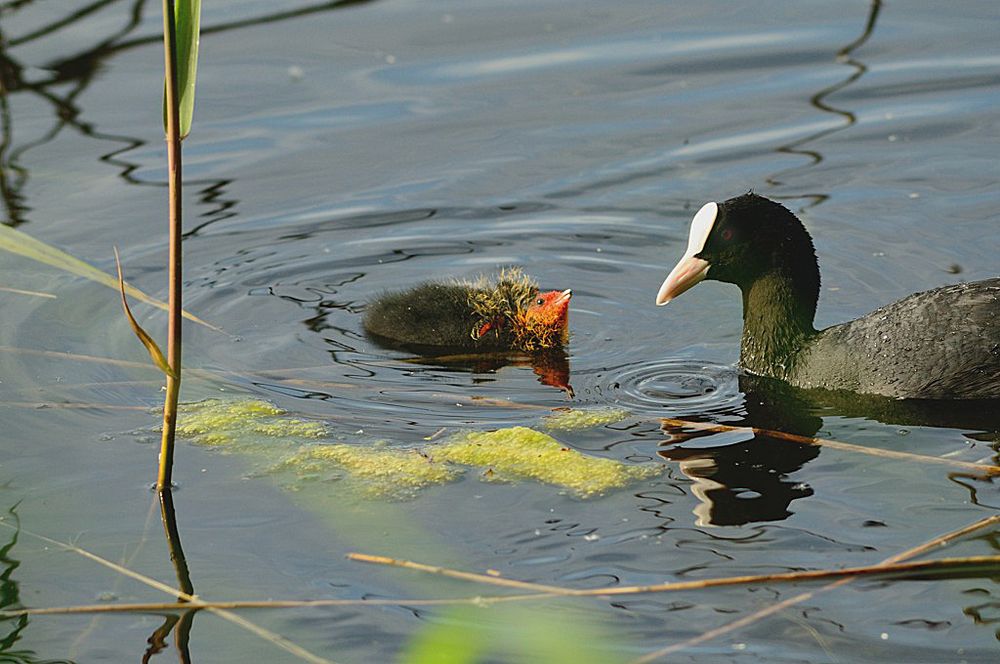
[656, 193, 819, 307]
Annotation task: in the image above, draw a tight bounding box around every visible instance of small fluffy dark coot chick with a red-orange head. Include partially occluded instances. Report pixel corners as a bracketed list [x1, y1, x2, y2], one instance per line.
[364, 269, 573, 352]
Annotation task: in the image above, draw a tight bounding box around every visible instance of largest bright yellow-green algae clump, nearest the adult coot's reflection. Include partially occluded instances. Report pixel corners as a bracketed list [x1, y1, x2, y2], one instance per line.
[434, 427, 662, 496]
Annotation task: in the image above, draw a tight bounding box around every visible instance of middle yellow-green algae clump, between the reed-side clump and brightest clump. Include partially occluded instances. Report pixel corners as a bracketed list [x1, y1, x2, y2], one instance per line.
[282, 444, 461, 498]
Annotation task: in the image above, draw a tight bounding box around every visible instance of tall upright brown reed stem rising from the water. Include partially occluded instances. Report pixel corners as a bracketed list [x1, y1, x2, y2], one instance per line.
[156, 0, 182, 491]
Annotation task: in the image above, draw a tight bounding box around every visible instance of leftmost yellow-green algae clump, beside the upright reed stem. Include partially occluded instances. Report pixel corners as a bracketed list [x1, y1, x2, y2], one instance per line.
[177, 399, 326, 445]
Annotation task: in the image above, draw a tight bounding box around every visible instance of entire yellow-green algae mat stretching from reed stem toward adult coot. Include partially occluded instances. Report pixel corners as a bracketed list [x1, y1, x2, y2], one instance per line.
[177, 398, 663, 499]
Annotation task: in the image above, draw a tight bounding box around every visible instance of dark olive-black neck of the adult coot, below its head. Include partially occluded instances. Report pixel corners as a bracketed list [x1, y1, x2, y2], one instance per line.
[740, 266, 819, 378]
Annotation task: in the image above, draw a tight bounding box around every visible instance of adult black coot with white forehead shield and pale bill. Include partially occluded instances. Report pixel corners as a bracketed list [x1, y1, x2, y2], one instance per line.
[656, 193, 1000, 399]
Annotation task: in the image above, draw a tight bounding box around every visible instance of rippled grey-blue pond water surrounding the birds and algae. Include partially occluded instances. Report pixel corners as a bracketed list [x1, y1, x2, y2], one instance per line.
[0, 0, 1000, 662]
